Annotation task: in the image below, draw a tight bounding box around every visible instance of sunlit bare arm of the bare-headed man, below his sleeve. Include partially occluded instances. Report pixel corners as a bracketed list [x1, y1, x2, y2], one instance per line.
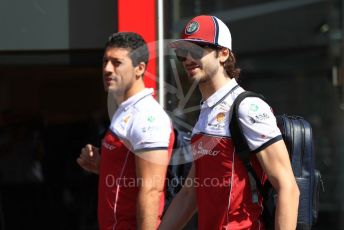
[135, 150, 169, 230]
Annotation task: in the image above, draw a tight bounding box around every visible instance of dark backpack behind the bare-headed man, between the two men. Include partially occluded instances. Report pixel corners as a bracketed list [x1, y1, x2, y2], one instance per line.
[164, 125, 192, 213]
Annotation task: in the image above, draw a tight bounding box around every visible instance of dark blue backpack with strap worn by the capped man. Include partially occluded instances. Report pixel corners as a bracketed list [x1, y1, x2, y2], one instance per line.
[229, 91, 323, 230]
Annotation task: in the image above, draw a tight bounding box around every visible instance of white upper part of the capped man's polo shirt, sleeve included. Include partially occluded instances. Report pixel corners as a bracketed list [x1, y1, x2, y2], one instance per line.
[193, 79, 281, 151]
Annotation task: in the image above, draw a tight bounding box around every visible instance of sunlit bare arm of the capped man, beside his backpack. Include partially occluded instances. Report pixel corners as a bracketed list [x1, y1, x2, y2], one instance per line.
[257, 140, 300, 230]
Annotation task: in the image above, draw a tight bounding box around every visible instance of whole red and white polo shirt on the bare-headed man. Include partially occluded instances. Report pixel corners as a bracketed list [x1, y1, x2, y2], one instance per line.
[98, 89, 174, 229]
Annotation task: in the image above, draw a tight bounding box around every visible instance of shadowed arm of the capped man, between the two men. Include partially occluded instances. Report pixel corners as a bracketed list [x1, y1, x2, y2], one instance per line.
[159, 164, 197, 230]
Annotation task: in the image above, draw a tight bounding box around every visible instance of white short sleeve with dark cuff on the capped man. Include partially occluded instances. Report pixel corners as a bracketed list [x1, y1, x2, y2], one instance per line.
[238, 97, 282, 152]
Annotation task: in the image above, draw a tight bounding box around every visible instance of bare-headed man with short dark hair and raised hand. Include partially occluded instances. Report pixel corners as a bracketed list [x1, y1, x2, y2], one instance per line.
[77, 32, 174, 229]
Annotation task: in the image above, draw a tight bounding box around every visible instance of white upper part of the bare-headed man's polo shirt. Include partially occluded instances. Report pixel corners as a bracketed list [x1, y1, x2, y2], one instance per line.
[110, 89, 172, 152]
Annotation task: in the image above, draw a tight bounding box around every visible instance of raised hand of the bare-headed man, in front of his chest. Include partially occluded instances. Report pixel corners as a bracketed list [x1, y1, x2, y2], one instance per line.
[76, 144, 100, 174]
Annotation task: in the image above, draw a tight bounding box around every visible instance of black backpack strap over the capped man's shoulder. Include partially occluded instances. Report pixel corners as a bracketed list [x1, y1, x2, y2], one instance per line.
[229, 91, 267, 203]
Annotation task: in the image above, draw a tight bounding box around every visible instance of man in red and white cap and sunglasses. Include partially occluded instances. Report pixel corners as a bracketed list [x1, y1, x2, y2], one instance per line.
[160, 15, 299, 230]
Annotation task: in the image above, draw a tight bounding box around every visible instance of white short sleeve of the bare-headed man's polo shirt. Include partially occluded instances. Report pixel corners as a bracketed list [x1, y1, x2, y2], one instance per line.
[128, 111, 172, 151]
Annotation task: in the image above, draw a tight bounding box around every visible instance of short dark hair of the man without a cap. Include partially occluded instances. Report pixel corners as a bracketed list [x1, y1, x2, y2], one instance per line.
[106, 32, 149, 66]
